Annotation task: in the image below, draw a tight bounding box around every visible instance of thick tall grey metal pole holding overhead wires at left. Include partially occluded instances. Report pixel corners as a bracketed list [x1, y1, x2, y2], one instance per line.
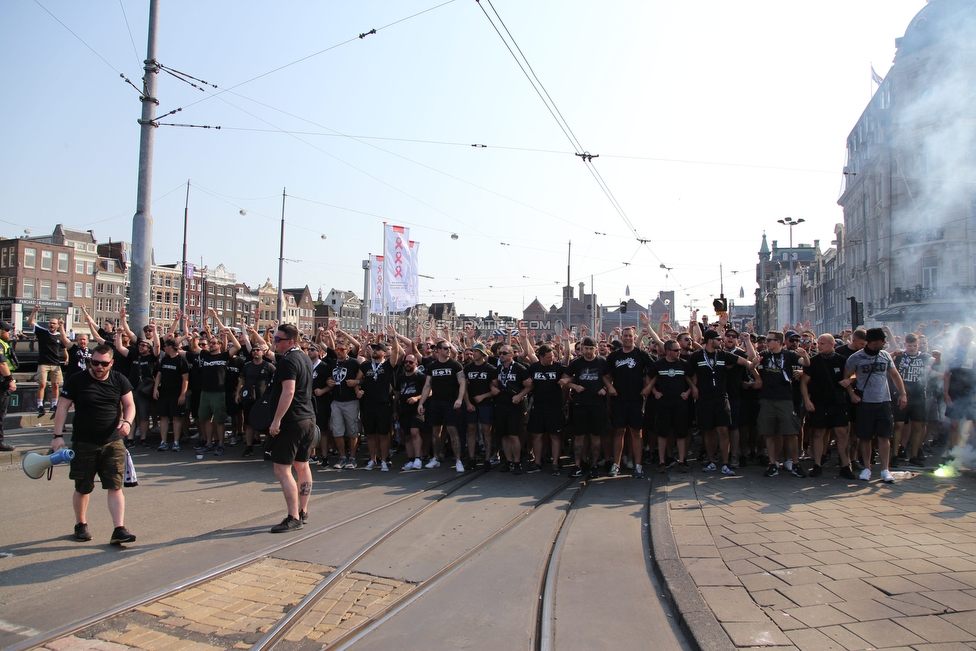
[129, 0, 159, 332]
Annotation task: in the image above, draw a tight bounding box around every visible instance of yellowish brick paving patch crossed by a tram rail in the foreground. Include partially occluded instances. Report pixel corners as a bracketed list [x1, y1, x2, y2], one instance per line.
[36, 558, 415, 651]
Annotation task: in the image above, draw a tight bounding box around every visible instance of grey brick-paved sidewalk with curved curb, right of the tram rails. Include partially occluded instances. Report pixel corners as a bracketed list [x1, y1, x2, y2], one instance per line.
[651, 464, 976, 651]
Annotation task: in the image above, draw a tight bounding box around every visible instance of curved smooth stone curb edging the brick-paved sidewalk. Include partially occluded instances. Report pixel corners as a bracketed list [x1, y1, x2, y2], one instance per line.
[648, 475, 736, 651]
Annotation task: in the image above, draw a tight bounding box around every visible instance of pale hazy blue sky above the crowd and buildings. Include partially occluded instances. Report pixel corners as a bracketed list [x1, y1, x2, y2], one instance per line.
[0, 0, 925, 322]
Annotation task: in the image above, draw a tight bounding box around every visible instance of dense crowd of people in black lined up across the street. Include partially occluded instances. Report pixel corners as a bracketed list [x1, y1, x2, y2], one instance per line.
[31, 312, 976, 482]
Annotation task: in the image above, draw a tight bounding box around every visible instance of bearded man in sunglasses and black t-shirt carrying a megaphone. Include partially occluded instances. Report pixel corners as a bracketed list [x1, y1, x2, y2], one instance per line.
[51, 344, 136, 545]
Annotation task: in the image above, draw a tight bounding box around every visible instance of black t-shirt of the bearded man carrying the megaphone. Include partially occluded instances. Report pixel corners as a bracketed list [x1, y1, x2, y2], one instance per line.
[61, 371, 132, 445]
